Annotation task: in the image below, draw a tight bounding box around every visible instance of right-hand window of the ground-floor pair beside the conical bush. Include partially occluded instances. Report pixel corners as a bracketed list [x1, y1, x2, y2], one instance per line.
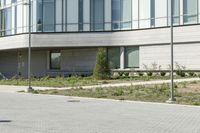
[125, 47, 139, 68]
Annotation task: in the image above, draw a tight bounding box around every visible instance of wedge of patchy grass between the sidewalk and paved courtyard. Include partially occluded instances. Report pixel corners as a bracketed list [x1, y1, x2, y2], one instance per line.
[33, 82, 200, 105]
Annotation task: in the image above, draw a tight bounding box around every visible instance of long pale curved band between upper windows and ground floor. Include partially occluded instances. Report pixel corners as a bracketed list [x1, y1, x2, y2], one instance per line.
[0, 25, 200, 50]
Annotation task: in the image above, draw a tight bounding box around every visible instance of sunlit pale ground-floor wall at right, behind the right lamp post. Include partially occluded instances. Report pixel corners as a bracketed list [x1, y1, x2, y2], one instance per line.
[140, 43, 200, 70]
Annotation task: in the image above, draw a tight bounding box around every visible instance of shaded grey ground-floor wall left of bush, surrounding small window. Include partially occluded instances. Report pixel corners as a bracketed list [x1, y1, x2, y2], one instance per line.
[0, 48, 97, 77]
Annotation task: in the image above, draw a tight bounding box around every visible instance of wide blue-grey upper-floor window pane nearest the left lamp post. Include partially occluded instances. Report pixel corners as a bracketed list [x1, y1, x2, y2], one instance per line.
[43, 0, 55, 32]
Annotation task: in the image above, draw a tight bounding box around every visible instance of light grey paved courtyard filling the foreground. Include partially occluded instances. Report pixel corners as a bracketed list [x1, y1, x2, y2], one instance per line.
[0, 92, 200, 133]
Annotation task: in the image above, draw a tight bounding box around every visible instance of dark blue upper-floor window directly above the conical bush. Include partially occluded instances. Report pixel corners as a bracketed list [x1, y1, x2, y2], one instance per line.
[90, 0, 104, 31]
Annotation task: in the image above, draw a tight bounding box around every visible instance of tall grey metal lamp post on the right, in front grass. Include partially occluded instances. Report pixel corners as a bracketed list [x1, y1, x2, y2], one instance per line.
[167, 0, 176, 103]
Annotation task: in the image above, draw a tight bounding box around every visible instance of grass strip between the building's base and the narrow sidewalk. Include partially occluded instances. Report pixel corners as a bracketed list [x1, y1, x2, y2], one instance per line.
[0, 75, 195, 88]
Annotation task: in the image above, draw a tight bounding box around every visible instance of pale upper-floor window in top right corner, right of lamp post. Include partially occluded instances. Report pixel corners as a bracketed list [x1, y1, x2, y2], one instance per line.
[183, 0, 198, 24]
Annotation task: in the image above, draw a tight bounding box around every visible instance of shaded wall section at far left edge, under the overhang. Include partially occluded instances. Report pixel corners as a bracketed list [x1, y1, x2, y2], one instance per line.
[0, 51, 18, 77]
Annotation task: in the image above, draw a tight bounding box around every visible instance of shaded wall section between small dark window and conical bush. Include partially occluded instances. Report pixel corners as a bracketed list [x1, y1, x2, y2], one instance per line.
[61, 48, 97, 72]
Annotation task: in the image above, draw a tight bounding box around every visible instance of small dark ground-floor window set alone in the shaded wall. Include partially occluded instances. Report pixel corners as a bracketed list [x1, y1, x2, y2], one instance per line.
[50, 51, 61, 70]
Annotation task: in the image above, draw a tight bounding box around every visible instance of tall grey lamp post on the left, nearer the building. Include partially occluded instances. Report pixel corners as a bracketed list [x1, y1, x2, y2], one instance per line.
[24, 0, 33, 92]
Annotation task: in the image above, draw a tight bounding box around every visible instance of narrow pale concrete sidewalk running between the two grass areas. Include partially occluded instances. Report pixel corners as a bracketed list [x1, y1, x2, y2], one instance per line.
[0, 78, 200, 92]
